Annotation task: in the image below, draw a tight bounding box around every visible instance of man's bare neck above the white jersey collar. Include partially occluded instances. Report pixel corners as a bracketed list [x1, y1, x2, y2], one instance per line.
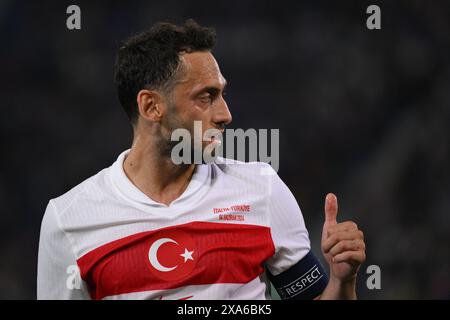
[123, 136, 195, 206]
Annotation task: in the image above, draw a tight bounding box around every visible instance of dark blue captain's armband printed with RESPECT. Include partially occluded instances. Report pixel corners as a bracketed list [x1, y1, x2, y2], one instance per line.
[267, 251, 328, 300]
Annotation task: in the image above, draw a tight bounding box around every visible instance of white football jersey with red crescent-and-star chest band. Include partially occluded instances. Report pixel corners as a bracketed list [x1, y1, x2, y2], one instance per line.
[37, 150, 310, 299]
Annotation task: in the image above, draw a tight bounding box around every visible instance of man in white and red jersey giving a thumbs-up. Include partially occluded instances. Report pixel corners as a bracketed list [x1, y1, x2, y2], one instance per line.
[37, 20, 365, 299]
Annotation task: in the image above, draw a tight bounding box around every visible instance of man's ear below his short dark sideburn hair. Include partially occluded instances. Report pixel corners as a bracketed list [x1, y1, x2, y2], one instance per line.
[137, 89, 164, 122]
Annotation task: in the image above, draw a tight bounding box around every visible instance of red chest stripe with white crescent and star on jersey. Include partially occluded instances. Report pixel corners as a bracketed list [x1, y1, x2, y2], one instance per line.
[77, 222, 275, 299]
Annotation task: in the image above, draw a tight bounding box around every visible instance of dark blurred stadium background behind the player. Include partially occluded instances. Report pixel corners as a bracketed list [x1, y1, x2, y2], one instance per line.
[0, 0, 450, 299]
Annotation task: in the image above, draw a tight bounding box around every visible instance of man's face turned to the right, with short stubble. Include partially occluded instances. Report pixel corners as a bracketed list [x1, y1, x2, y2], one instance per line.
[163, 52, 232, 157]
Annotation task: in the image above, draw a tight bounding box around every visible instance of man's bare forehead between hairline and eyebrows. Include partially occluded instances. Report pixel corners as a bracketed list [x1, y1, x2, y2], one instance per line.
[176, 51, 226, 88]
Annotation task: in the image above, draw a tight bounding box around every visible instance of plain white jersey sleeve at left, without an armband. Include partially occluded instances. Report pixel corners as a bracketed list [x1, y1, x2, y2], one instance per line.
[37, 201, 90, 300]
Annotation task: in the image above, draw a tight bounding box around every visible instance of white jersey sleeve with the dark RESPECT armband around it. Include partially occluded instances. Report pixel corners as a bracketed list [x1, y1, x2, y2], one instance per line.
[266, 172, 328, 300]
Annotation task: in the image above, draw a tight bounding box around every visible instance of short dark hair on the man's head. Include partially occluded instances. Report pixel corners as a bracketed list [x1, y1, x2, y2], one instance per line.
[114, 19, 216, 124]
